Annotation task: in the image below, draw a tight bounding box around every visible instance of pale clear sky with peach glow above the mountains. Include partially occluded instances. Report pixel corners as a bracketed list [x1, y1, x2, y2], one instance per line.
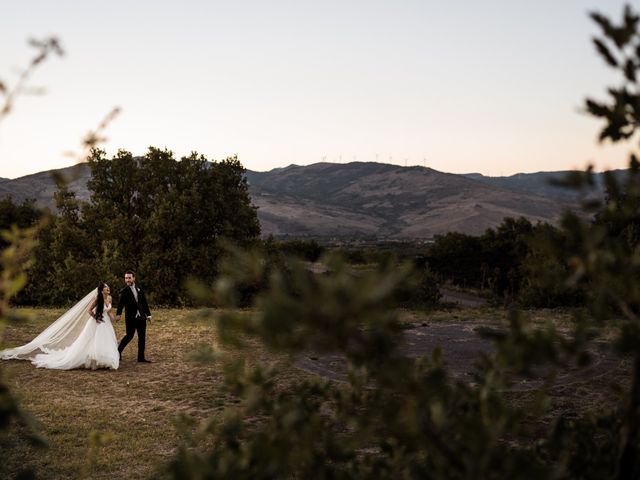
[0, 0, 639, 178]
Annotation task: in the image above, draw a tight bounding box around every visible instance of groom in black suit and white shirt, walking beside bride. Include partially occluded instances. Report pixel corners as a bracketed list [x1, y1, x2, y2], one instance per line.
[116, 270, 151, 363]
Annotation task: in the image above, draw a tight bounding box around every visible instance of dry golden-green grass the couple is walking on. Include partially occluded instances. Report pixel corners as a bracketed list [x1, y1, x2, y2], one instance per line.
[0, 309, 304, 479]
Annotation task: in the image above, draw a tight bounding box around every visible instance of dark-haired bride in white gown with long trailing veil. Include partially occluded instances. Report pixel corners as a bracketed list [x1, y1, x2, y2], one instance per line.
[0, 283, 120, 370]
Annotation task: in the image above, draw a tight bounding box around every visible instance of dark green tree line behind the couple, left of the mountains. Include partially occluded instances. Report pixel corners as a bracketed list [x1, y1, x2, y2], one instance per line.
[6, 147, 260, 305]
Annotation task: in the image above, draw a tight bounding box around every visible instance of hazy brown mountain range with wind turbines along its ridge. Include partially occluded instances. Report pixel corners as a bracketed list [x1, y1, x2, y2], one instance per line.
[0, 162, 623, 239]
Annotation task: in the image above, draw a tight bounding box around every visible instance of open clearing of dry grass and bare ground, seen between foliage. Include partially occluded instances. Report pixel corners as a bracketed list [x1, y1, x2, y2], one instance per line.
[0, 307, 626, 479]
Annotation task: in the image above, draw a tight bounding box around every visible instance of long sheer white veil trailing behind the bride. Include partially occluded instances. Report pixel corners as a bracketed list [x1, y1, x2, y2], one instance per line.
[0, 288, 97, 360]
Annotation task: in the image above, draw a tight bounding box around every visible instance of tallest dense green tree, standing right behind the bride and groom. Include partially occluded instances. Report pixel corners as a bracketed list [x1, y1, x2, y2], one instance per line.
[83, 147, 260, 304]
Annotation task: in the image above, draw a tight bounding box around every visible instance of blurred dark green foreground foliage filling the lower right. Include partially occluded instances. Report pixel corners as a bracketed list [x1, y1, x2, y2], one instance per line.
[169, 8, 640, 479]
